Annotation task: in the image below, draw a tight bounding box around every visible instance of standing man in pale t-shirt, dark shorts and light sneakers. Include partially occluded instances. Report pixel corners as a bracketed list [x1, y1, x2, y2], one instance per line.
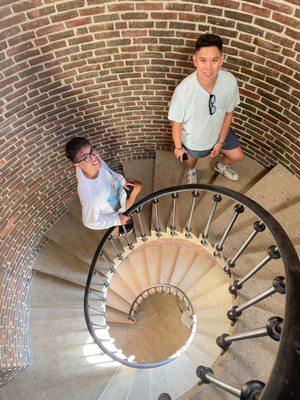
[168, 33, 243, 183]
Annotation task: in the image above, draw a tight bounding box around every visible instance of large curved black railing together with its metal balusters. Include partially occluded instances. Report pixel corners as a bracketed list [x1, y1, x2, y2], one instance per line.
[84, 184, 300, 400]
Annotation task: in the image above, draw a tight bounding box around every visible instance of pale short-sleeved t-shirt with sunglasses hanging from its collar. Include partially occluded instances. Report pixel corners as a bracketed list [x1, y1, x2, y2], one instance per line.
[168, 69, 240, 150]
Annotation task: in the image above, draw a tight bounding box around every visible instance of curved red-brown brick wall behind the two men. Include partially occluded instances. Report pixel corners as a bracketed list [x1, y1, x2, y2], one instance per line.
[0, 0, 300, 384]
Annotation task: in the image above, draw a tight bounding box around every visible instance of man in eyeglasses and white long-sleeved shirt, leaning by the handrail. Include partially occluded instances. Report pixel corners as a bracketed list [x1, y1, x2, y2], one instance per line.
[65, 137, 142, 236]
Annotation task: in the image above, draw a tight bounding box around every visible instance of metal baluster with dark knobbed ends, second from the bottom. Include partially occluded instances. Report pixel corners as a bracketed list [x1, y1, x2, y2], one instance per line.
[216, 317, 283, 352]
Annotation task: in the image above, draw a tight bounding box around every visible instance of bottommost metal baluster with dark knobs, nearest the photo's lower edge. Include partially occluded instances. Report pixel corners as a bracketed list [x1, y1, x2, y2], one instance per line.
[196, 365, 265, 400]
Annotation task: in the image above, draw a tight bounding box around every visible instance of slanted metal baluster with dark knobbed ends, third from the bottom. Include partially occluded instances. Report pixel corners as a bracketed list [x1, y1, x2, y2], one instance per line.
[227, 276, 285, 322]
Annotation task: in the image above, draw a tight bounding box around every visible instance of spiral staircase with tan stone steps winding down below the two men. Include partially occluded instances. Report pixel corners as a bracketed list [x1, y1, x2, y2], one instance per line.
[1, 151, 300, 400]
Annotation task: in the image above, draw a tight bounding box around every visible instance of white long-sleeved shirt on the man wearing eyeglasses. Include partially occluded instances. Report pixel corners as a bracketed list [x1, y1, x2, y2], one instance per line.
[76, 160, 126, 229]
